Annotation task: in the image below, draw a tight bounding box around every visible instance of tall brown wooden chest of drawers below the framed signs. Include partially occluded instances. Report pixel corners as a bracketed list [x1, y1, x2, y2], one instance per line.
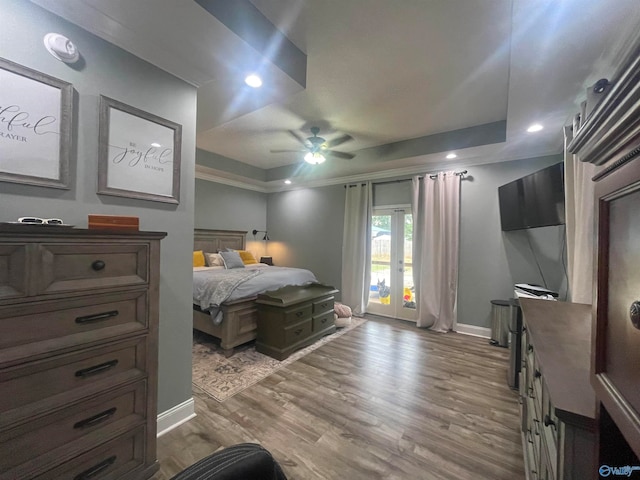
[0, 224, 166, 480]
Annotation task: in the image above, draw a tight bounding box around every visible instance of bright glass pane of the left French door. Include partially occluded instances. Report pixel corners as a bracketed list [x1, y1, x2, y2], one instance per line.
[369, 215, 391, 305]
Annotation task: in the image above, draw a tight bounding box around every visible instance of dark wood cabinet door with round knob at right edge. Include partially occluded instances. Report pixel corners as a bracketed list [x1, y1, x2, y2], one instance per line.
[594, 161, 640, 454]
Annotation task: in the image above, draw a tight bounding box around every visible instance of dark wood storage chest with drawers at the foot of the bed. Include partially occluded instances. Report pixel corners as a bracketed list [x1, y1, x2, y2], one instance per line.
[256, 283, 338, 360]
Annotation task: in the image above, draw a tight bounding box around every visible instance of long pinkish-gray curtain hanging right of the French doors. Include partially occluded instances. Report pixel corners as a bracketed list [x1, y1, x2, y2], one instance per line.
[411, 172, 460, 332]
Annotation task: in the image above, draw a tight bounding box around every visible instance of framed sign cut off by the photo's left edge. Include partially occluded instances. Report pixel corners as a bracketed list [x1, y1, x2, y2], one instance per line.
[0, 58, 74, 190]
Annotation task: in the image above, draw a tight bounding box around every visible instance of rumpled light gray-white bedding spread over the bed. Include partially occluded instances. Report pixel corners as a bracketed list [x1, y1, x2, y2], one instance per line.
[193, 263, 317, 310]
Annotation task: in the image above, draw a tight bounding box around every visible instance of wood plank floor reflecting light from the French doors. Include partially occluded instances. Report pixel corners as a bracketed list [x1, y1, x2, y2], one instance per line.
[153, 317, 524, 480]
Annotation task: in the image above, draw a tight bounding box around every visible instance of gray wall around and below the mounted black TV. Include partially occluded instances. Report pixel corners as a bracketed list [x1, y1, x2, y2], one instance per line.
[458, 155, 566, 327]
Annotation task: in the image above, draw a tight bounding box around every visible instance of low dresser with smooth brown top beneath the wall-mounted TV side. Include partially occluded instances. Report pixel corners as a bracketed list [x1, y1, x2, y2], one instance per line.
[520, 298, 598, 480]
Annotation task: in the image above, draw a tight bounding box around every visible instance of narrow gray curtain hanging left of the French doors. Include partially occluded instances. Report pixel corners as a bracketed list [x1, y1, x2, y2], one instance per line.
[342, 182, 373, 315]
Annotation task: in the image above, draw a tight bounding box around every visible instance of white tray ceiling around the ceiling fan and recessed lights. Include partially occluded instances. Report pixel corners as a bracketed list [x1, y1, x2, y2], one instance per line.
[32, 0, 640, 186]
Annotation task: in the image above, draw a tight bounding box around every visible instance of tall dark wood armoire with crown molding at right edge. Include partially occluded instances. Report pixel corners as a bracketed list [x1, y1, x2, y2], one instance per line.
[569, 36, 640, 468]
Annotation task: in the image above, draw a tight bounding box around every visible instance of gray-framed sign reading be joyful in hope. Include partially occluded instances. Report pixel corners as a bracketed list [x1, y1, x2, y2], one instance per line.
[98, 95, 182, 204]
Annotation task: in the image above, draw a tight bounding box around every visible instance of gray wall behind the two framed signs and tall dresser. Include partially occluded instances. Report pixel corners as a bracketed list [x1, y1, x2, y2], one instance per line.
[0, 0, 196, 412]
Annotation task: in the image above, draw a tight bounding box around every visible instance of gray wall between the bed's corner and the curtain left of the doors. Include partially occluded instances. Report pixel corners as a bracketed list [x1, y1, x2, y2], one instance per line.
[267, 185, 345, 289]
